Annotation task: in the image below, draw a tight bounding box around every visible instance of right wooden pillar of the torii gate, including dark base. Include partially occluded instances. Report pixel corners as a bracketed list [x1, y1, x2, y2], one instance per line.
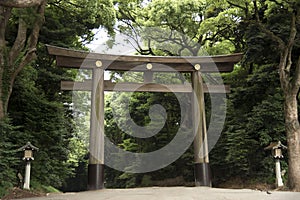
[192, 69, 211, 187]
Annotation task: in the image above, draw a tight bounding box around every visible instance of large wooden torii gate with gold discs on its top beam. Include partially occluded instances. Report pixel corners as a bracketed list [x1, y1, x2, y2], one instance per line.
[47, 45, 242, 190]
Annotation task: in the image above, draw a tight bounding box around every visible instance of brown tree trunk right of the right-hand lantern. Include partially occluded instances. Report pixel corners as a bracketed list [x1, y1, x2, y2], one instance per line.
[273, 8, 300, 192]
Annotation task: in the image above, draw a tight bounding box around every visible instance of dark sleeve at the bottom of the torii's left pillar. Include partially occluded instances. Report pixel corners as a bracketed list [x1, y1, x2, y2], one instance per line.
[88, 164, 104, 190]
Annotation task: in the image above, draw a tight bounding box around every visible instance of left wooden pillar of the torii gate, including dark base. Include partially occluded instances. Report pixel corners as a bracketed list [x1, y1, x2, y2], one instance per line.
[88, 64, 104, 190]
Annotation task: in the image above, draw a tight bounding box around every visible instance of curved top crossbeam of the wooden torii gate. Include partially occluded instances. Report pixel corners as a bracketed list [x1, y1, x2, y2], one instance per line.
[47, 45, 242, 73]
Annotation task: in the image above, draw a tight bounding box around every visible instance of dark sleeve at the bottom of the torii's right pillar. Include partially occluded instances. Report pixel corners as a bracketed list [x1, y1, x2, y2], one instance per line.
[195, 163, 211, 187]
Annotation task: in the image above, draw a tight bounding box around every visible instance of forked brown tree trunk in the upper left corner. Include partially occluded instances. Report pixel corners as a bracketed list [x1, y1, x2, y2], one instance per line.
[0, 0, 47, 120]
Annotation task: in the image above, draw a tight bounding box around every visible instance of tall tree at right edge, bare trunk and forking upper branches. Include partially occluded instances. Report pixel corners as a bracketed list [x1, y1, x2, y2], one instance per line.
[262, 1, 300, 191]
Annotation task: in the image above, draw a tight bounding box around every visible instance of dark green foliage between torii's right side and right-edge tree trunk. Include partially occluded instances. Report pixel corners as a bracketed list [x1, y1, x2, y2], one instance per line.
[206, 1, 299, 186]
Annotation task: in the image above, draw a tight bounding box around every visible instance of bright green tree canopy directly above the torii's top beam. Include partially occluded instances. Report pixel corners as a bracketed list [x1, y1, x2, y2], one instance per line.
[116, 0, 241, 56]
